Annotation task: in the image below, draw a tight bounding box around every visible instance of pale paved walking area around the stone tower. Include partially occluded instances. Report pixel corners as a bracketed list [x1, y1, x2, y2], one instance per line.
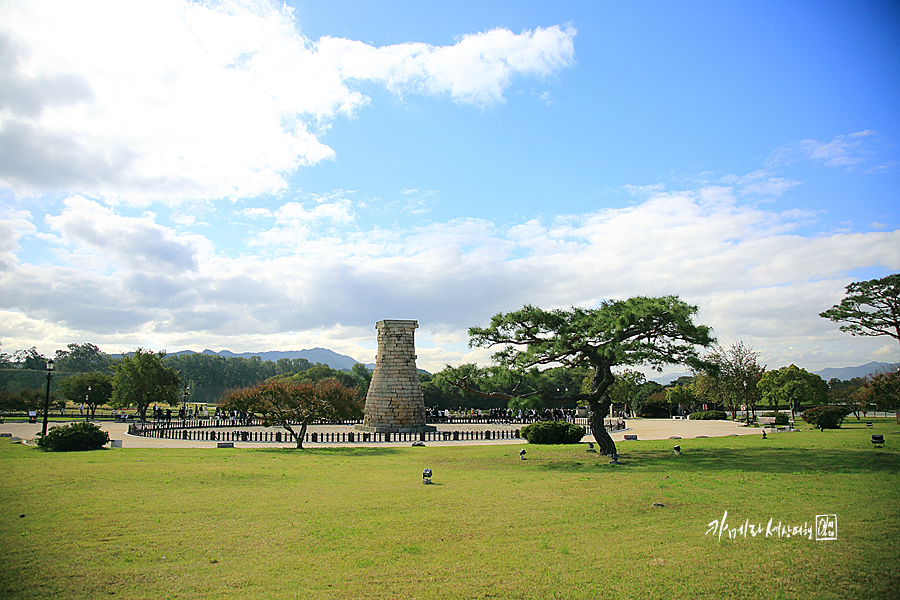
[0, 419, 772, 448]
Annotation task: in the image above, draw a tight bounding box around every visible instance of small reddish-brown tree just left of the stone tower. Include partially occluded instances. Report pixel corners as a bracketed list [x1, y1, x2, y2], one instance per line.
[222, 378, 363, 449]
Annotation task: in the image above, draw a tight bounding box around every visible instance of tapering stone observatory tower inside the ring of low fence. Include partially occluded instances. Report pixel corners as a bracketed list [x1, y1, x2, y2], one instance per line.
[356, 320, 435, 433]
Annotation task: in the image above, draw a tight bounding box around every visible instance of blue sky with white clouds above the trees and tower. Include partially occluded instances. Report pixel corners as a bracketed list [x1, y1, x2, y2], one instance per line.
[0, 0, 900, 370]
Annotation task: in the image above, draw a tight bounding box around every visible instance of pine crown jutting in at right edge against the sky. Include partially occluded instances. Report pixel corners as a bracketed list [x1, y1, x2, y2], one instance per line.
[819, 273, 900, 350]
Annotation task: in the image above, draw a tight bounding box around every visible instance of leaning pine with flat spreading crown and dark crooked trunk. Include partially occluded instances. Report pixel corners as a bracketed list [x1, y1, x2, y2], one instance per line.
[460, 296, 714, 454]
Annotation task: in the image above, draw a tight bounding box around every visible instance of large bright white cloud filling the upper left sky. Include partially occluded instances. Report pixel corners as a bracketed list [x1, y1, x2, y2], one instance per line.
[0, 0, 575, 203]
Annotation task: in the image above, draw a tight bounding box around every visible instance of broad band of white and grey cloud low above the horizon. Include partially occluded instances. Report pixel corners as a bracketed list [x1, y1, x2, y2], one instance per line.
[0, 180, 900, 370]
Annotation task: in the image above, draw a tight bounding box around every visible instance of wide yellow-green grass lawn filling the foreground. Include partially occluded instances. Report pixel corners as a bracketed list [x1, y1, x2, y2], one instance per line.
[0, 419, 900, 600]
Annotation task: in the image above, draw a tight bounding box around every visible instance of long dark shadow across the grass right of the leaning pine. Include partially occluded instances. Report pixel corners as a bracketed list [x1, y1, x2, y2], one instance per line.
[535, 448, 900, 474]
